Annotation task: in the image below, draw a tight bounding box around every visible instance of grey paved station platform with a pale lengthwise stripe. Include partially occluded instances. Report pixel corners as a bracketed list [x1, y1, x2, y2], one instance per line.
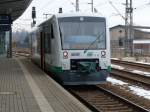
[0, 58, 90, 112]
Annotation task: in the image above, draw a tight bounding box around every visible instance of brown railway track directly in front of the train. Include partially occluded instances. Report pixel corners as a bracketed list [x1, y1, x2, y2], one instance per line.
[67, 86, 150, 112]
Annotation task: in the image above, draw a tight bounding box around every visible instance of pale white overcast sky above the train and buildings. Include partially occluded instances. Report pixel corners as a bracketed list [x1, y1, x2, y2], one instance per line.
[13, 0, 150, 31]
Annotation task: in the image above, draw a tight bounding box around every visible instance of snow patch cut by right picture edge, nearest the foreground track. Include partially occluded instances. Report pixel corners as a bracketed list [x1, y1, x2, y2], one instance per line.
[129, 86, 150, 99]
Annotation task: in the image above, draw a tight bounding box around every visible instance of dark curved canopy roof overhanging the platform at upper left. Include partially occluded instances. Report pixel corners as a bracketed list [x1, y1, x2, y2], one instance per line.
[0, 0, 32, 21]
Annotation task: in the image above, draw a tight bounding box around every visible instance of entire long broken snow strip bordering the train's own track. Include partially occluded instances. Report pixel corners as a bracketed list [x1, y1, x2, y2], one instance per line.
[107, 77, 150, 100]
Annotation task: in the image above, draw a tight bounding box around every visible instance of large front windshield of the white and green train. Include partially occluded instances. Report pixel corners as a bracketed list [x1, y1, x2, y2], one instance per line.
[59, 17, 106, 50]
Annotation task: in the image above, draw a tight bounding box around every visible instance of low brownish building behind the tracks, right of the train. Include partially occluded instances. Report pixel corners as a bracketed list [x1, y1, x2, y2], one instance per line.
[110, 25, 150, 58]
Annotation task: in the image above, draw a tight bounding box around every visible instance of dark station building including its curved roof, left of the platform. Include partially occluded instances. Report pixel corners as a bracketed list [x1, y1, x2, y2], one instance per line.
[0, 0, 32, 58]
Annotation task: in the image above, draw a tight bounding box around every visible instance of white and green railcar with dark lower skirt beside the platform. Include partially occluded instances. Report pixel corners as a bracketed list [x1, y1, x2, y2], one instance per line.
[31, 14, 111, 85]
